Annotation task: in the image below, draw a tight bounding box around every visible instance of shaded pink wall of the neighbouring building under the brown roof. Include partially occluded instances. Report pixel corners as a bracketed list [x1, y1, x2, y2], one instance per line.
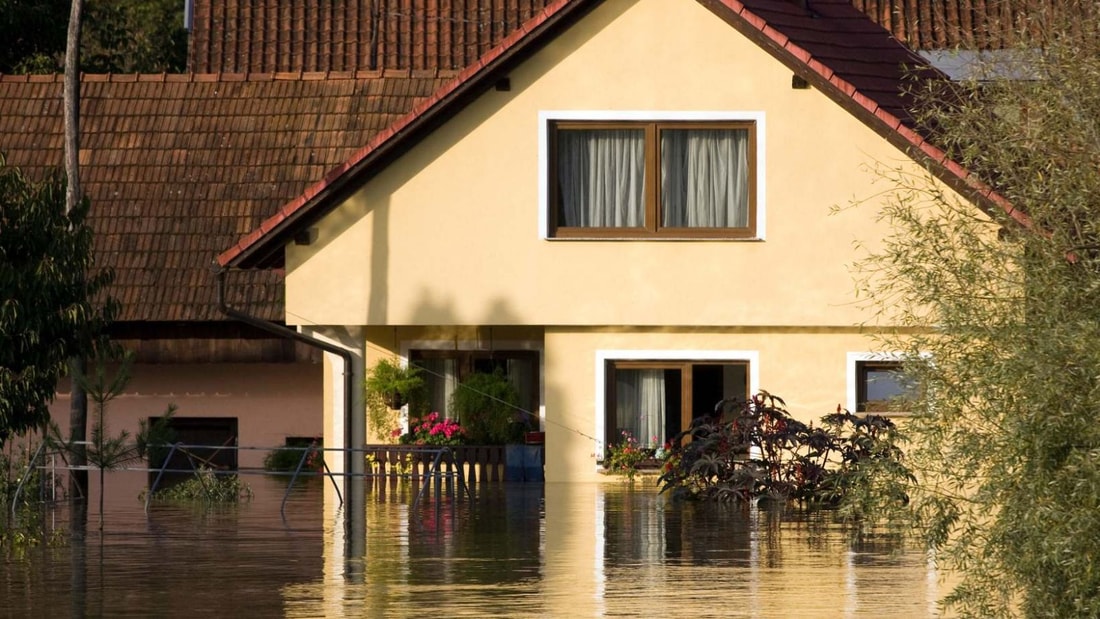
[50, 363, 323, 467]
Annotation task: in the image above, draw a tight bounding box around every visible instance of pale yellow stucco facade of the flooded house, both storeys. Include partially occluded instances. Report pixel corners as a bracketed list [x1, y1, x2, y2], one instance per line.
[286, 0, 968, 482]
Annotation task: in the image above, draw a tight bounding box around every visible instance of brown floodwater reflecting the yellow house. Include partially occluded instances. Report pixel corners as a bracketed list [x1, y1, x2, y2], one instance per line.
[0, 473, 943, 618]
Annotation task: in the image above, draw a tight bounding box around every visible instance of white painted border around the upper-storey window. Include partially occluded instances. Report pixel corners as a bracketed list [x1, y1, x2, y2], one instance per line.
[539, 110, 768, 242]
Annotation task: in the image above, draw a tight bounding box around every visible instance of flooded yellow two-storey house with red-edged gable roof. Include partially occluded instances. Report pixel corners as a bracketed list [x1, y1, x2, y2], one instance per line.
[218, 0, 1012, 482]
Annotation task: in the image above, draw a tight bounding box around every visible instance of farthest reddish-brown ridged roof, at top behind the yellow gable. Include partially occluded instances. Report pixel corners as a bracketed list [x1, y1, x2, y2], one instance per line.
[188, 0, 1038, 73]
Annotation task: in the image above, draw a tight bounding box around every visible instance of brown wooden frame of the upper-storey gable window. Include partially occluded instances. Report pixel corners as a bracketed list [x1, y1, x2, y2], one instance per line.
[547, 120, 759, 240]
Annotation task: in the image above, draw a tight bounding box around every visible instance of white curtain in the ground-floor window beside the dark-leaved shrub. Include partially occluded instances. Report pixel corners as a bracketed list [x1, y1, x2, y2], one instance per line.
[608, 369, 666, 446]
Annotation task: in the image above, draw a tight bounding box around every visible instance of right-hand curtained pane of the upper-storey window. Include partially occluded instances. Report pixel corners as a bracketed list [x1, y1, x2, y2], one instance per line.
[661, 129, 749, 228]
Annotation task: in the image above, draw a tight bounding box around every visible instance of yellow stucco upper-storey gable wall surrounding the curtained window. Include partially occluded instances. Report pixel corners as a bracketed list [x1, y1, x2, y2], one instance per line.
[287, 0, 919, 325]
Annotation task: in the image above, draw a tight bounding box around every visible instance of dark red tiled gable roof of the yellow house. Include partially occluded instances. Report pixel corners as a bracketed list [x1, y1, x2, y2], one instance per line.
[218, 0, 1020, 268]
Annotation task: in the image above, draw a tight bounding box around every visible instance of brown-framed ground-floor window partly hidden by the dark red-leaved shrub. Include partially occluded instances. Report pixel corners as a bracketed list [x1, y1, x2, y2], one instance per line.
[604, 360, 749, 447]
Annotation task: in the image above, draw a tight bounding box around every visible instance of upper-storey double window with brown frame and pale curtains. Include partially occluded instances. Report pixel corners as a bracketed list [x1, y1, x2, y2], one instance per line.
[548, 120, 757, 239]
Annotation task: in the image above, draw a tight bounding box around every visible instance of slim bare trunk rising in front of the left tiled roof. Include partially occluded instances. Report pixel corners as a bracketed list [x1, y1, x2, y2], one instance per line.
[64, 0, 88, 521]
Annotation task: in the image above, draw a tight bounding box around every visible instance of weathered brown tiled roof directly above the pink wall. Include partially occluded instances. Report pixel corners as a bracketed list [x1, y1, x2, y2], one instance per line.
[0, 71, 454, 322]
